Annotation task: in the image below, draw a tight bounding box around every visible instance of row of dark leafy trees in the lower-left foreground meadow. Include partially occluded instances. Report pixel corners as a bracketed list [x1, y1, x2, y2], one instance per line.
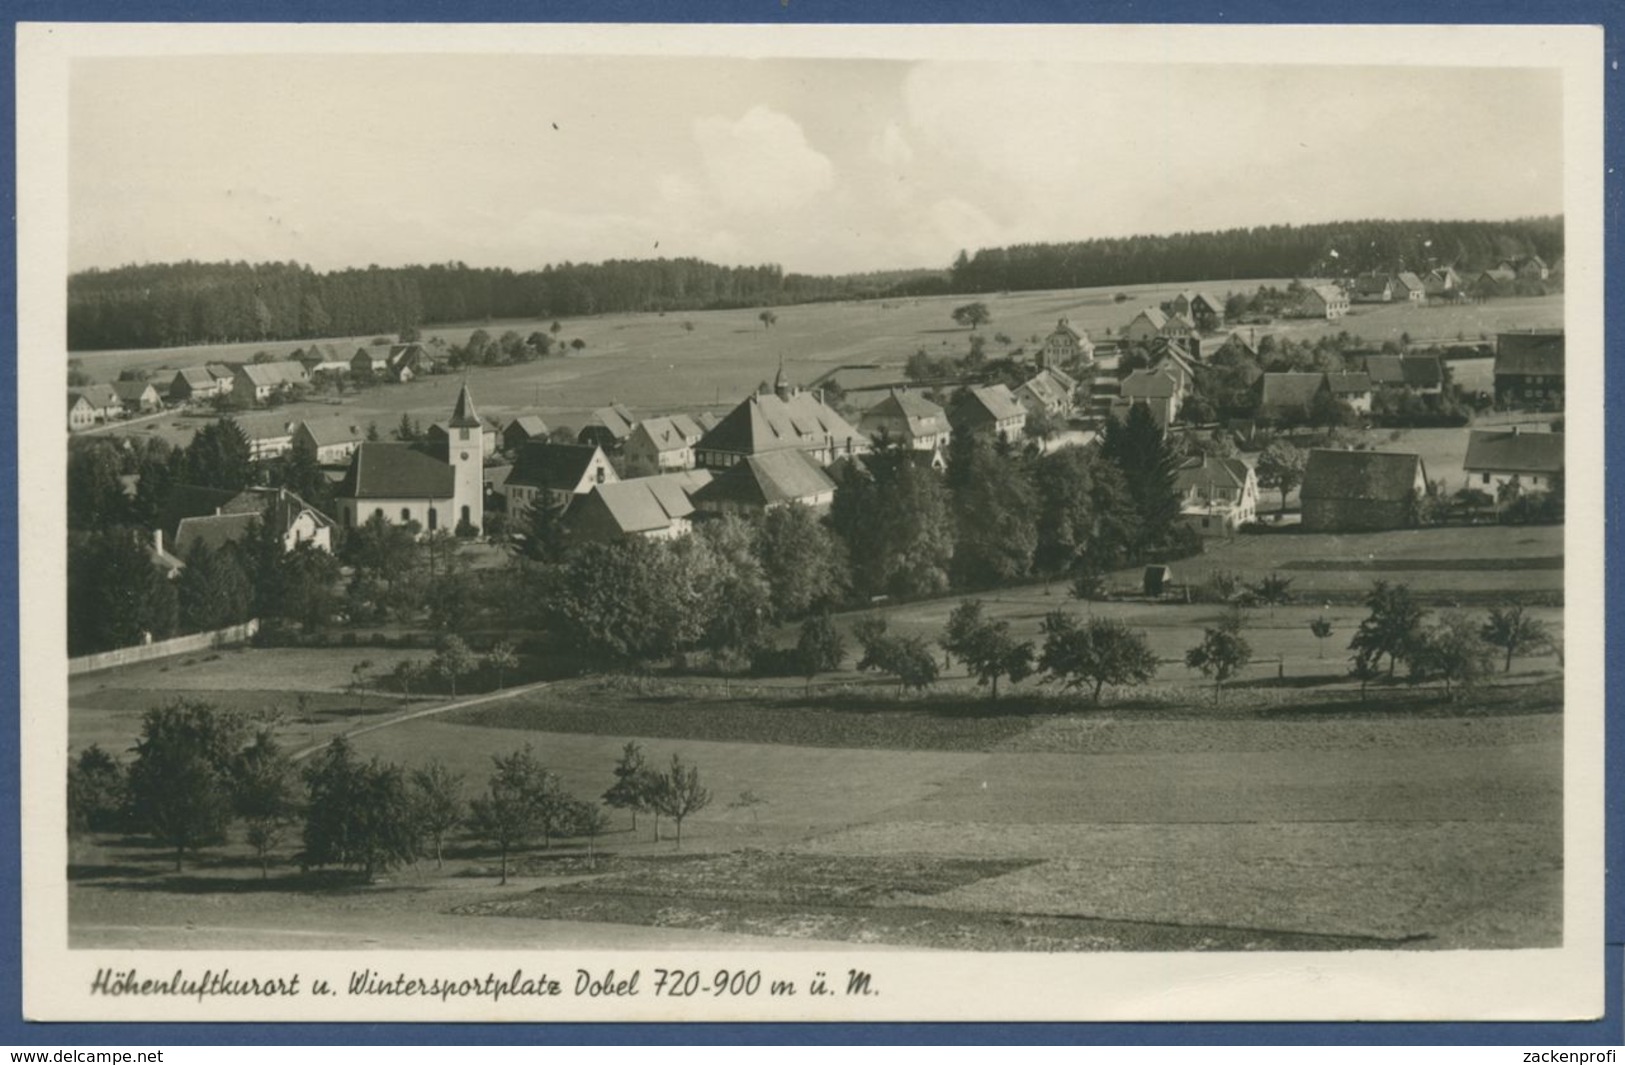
[67, 699, 712, 885]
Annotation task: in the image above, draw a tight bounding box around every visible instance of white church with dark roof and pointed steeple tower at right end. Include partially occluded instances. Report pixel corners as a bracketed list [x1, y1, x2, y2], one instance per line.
[335, 384, 486, 532]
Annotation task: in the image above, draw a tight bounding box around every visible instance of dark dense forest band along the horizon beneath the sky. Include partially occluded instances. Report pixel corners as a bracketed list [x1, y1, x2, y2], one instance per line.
[67, 216, 1563, 351]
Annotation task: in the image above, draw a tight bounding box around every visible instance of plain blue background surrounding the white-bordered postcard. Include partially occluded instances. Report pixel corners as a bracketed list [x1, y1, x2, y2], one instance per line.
[0, 0, 1625, 1047]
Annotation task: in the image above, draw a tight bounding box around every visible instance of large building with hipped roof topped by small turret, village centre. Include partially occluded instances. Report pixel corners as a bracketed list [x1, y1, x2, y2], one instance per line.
[694, 374, 869, 470]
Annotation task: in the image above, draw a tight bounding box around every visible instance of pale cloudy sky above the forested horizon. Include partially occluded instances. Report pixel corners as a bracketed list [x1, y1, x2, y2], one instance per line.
[68, 54, 1563, 273]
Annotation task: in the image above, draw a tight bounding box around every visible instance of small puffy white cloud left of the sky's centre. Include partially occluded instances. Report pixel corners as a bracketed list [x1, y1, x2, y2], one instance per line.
[694, 106, 835, 213]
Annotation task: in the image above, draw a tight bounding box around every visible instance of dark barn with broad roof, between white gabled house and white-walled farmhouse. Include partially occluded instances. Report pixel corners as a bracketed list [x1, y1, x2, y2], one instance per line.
[1298, 447, 1427, 532]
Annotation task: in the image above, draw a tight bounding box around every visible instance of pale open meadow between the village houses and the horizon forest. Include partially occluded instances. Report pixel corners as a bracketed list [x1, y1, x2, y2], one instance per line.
[75, 280, 1563, 442]
